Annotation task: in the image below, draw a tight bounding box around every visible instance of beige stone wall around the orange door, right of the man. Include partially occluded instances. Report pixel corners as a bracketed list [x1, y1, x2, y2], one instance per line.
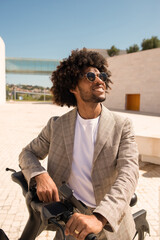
[104, 48, 160, 114]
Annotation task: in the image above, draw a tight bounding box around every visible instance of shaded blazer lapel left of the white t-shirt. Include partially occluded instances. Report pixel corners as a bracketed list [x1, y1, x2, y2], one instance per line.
[61, 108, 77, 163]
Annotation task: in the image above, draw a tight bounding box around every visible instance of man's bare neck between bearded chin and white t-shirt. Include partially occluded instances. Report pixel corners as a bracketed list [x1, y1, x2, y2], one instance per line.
[77, 103, 102, 119]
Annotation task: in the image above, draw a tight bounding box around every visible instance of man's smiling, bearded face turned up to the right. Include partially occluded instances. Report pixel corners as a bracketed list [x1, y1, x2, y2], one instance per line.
[73, 67, 106, 103]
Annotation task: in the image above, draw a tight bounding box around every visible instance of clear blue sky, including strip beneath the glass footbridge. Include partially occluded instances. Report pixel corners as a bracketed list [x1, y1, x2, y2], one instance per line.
[0, 0, 160, 86]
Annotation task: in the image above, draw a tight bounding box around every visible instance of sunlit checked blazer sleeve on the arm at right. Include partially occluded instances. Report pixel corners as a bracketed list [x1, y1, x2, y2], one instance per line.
[94, 119, 139, 231]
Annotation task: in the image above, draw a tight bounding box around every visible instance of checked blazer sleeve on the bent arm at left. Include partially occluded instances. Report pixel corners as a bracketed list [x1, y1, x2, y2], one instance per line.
[19, 118, 54, 185]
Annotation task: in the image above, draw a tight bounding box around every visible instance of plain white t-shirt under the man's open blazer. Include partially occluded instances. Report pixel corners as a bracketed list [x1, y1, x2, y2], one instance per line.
[68, 113, 99, 208]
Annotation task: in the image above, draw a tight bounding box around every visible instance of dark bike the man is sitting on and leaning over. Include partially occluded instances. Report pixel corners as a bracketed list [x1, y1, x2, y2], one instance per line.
[0, 168, 149, 240]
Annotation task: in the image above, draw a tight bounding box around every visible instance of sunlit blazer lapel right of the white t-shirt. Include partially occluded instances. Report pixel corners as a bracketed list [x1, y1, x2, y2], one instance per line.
[93, 105, 115, 164]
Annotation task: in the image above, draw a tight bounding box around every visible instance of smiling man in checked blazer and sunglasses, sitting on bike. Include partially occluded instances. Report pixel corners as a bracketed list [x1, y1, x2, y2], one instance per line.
[20, 48, 138, 240]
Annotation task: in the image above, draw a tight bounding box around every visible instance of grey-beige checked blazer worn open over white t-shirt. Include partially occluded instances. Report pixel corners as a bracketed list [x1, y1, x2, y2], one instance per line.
[19, 105, 139, 240]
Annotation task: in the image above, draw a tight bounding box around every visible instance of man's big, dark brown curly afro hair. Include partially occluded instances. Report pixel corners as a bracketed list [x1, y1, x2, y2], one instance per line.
[51, 48, 112, 107]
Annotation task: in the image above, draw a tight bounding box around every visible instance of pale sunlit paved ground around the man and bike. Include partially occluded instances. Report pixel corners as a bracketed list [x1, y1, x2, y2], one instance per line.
[0, 103, 160, 240]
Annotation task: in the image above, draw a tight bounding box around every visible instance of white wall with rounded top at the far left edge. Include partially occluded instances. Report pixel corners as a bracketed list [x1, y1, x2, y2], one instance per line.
[0, 37, 6, 104]
